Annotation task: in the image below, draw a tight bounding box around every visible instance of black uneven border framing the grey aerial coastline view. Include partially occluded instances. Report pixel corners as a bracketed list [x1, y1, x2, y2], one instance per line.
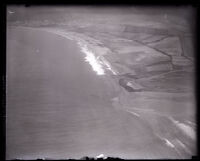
[0, 0, 200, 160]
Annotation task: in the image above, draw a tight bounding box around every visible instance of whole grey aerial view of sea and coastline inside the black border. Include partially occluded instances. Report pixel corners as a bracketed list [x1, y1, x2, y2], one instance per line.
[6, 6, 196, 160]
